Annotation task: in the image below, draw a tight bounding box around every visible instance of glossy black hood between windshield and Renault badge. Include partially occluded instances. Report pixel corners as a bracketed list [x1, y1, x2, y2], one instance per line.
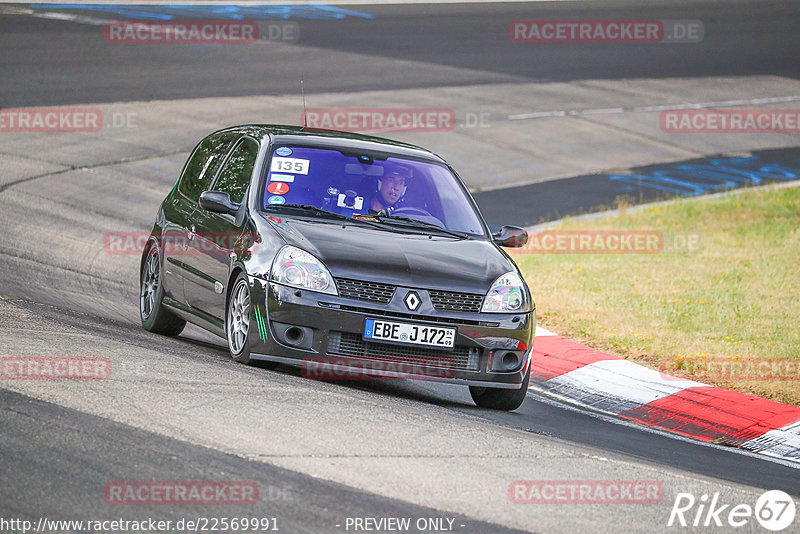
[262, 219, 516, 293]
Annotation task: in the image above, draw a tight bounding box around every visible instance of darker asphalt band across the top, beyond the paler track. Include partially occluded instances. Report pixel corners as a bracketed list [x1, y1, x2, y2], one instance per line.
[0, 0, 800, 107]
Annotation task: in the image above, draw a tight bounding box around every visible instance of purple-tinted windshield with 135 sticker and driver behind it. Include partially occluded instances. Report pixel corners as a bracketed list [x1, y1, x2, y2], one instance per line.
[263, 145, 485, 236]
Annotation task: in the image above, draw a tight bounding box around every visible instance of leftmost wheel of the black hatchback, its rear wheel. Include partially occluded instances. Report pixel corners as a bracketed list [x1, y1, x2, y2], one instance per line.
[139, 244, 186, 336]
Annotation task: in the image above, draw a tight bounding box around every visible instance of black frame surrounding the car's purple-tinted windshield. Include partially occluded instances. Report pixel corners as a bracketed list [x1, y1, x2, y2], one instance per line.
[256, 139, 491, 240]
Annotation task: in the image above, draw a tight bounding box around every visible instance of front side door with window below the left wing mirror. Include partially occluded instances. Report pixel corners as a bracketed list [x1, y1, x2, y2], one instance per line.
[184, 137, 259, 325]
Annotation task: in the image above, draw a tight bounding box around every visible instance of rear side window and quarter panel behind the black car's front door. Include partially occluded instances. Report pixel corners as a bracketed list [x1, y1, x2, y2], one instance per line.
[162, 133, 238, 304]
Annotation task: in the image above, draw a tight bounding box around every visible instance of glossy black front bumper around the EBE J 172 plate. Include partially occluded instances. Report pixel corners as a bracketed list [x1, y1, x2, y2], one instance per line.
[248, 277, 535, 389]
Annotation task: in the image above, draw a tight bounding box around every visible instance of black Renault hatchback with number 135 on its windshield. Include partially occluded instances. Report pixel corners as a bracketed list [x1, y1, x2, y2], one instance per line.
[140, 125, 535, 410]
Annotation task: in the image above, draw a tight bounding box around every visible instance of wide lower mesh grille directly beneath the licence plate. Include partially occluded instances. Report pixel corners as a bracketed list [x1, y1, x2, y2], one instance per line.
[328, 332, 480, 370]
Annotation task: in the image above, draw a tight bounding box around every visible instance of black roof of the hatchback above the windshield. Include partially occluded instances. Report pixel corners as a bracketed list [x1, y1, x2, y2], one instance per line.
[212, 124, 446, 164]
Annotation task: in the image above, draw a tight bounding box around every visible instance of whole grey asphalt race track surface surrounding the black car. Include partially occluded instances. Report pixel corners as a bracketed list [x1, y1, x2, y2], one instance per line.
[0, 0, 800, 533]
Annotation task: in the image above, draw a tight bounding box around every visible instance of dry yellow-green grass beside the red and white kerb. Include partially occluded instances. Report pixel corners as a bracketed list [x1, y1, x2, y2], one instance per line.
[514, 187, 800, 405]
